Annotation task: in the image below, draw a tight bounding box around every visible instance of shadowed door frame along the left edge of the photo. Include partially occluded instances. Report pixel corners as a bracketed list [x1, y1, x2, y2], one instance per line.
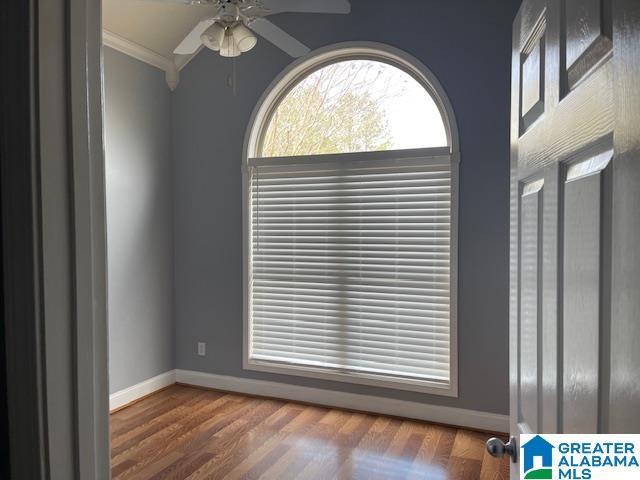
[0, 0, 110, 479]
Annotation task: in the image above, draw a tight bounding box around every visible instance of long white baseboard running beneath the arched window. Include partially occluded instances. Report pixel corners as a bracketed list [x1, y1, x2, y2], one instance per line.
[175, 370, 509, 432]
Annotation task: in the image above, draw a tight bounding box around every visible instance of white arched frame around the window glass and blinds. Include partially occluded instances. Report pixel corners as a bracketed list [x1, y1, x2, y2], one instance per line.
[242, 42, 460, 397]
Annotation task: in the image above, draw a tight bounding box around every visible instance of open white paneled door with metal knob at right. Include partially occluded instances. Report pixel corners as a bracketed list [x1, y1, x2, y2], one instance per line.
[488, 0, 640, 478]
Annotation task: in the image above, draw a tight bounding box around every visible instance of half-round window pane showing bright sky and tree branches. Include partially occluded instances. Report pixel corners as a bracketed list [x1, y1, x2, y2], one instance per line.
[262, 60, 447, 157]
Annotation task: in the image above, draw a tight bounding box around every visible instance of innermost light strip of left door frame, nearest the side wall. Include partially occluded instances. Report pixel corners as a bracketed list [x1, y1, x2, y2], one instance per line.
[72, 0, 111, 478]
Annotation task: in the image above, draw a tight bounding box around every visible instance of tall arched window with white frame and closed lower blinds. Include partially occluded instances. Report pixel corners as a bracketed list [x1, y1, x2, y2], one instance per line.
[244, 44, 458, 396]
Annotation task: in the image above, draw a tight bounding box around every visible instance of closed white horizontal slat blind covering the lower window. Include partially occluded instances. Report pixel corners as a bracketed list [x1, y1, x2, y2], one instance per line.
[248, 149, 452, 394]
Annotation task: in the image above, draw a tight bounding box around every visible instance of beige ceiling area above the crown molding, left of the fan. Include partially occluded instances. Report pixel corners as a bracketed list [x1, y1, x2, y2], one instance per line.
[102, 0, 215, 59]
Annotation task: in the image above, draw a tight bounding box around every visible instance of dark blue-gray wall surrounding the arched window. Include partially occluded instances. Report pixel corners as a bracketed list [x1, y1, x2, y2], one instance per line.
[172, 0, 519, 413]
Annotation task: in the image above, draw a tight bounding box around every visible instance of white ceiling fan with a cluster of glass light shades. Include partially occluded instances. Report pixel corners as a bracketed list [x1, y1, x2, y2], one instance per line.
[173, 0, 351, 57]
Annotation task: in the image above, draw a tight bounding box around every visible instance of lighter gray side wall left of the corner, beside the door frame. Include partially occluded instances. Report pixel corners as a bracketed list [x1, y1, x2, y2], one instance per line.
[104, 48, 175, 393]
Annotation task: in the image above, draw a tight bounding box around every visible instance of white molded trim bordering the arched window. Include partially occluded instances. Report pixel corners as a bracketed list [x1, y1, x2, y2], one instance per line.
[242, 42, 460, 398]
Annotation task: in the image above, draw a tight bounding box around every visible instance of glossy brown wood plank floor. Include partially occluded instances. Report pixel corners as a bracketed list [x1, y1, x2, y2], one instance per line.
[111, 385, 509, 480]
